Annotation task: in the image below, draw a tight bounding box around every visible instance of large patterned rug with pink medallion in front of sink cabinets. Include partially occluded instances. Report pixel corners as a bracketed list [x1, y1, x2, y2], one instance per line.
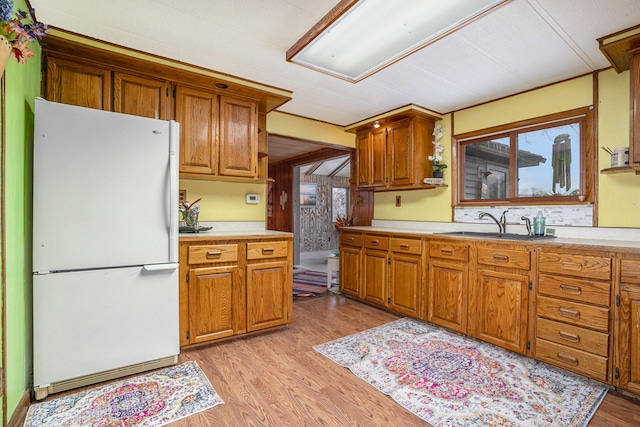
[314, 319, 607, 427]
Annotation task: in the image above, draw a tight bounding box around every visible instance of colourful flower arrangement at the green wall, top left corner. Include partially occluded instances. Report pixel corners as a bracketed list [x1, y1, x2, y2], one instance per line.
[0, 0, 49, 64]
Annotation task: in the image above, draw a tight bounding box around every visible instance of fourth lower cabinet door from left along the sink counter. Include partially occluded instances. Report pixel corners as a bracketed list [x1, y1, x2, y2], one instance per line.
[427, 260, 469, 333]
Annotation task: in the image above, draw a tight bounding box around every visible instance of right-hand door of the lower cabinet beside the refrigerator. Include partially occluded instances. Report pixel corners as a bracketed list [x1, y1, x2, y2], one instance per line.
[247, 261, 293, 332]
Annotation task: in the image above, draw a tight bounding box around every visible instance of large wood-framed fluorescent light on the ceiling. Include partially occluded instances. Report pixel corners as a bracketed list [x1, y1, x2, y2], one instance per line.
[287, 0, 510, 82]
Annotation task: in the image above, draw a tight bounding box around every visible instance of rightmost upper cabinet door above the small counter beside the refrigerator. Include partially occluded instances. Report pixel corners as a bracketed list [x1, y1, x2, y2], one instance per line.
[218, 96, 258, 178]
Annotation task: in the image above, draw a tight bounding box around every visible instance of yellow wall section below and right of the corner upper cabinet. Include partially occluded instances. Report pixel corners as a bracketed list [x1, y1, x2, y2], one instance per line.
[373, 114, 452, 222]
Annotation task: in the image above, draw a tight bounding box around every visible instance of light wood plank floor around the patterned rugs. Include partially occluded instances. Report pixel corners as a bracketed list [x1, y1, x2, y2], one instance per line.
[171, 294, 640, 427]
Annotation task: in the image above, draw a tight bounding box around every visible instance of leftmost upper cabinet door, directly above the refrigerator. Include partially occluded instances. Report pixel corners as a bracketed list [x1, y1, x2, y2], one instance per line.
[46, 57, 111, 111]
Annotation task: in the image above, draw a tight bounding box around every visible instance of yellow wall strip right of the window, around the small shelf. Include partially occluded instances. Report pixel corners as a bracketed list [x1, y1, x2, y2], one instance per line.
[598, 70, 640, 227]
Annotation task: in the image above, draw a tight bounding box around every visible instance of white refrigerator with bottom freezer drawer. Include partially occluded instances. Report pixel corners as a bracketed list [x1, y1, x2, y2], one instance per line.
[33, 98, 180, 399]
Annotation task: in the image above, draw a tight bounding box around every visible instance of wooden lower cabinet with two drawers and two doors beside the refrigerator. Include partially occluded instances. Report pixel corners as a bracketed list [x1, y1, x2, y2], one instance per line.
[180, 237, 293, 346]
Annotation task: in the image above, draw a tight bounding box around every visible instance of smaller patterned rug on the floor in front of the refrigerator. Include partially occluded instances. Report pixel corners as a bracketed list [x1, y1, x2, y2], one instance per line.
[24, 362, 224, 427]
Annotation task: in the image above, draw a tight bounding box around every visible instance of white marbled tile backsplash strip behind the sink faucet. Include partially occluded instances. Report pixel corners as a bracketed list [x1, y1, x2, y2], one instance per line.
[453, 204, 593, 227]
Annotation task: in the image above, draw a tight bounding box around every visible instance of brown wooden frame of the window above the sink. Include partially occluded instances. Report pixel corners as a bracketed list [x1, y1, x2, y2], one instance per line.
[451, 106, 597, 206]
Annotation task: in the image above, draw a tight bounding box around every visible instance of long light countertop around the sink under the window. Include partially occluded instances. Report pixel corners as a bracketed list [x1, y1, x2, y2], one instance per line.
[344, 220, 640, 249]
